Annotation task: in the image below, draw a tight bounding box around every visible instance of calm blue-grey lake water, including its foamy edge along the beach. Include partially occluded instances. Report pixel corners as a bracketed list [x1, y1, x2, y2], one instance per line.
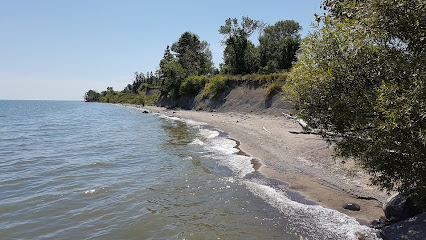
[0, 101, 378, 239]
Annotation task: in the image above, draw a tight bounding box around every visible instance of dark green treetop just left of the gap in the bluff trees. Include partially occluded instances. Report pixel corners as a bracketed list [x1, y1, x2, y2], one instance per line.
[171, 32, 213, 76]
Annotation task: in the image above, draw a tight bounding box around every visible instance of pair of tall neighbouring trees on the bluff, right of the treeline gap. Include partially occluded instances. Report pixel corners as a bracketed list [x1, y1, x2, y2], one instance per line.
[219, 17, 302, 74]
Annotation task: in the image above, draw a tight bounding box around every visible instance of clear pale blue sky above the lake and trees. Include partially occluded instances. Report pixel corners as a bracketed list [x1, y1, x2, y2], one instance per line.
[0, 0, 321, 101]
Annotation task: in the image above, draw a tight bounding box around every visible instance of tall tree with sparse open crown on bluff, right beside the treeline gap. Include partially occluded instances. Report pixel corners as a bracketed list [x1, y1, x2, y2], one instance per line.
[219, 17, 262, 74]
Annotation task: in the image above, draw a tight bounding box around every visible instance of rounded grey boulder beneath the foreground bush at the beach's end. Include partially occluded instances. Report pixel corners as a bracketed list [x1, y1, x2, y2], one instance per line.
[383, 194, 421, 223]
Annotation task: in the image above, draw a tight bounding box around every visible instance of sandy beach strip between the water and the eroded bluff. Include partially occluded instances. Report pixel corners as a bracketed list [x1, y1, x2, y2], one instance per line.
[144, 106, 388, 224]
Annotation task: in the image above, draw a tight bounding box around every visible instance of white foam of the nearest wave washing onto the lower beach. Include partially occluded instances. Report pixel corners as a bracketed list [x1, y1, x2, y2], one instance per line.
[243, 180, 380, 240]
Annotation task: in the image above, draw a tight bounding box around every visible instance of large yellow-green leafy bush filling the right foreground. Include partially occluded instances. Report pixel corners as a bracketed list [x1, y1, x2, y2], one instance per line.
[286, 0, 426, 206]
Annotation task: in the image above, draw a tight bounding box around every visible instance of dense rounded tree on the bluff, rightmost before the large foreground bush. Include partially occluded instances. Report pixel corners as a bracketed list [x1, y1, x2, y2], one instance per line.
[259, 20, 302, 73]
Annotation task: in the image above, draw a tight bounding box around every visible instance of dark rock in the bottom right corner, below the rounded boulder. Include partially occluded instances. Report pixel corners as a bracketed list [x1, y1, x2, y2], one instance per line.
[380, 212, 426, 240]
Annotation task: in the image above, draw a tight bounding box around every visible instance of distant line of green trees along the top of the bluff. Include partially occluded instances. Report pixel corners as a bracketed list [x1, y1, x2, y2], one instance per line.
[85, 17, 301, 103]
